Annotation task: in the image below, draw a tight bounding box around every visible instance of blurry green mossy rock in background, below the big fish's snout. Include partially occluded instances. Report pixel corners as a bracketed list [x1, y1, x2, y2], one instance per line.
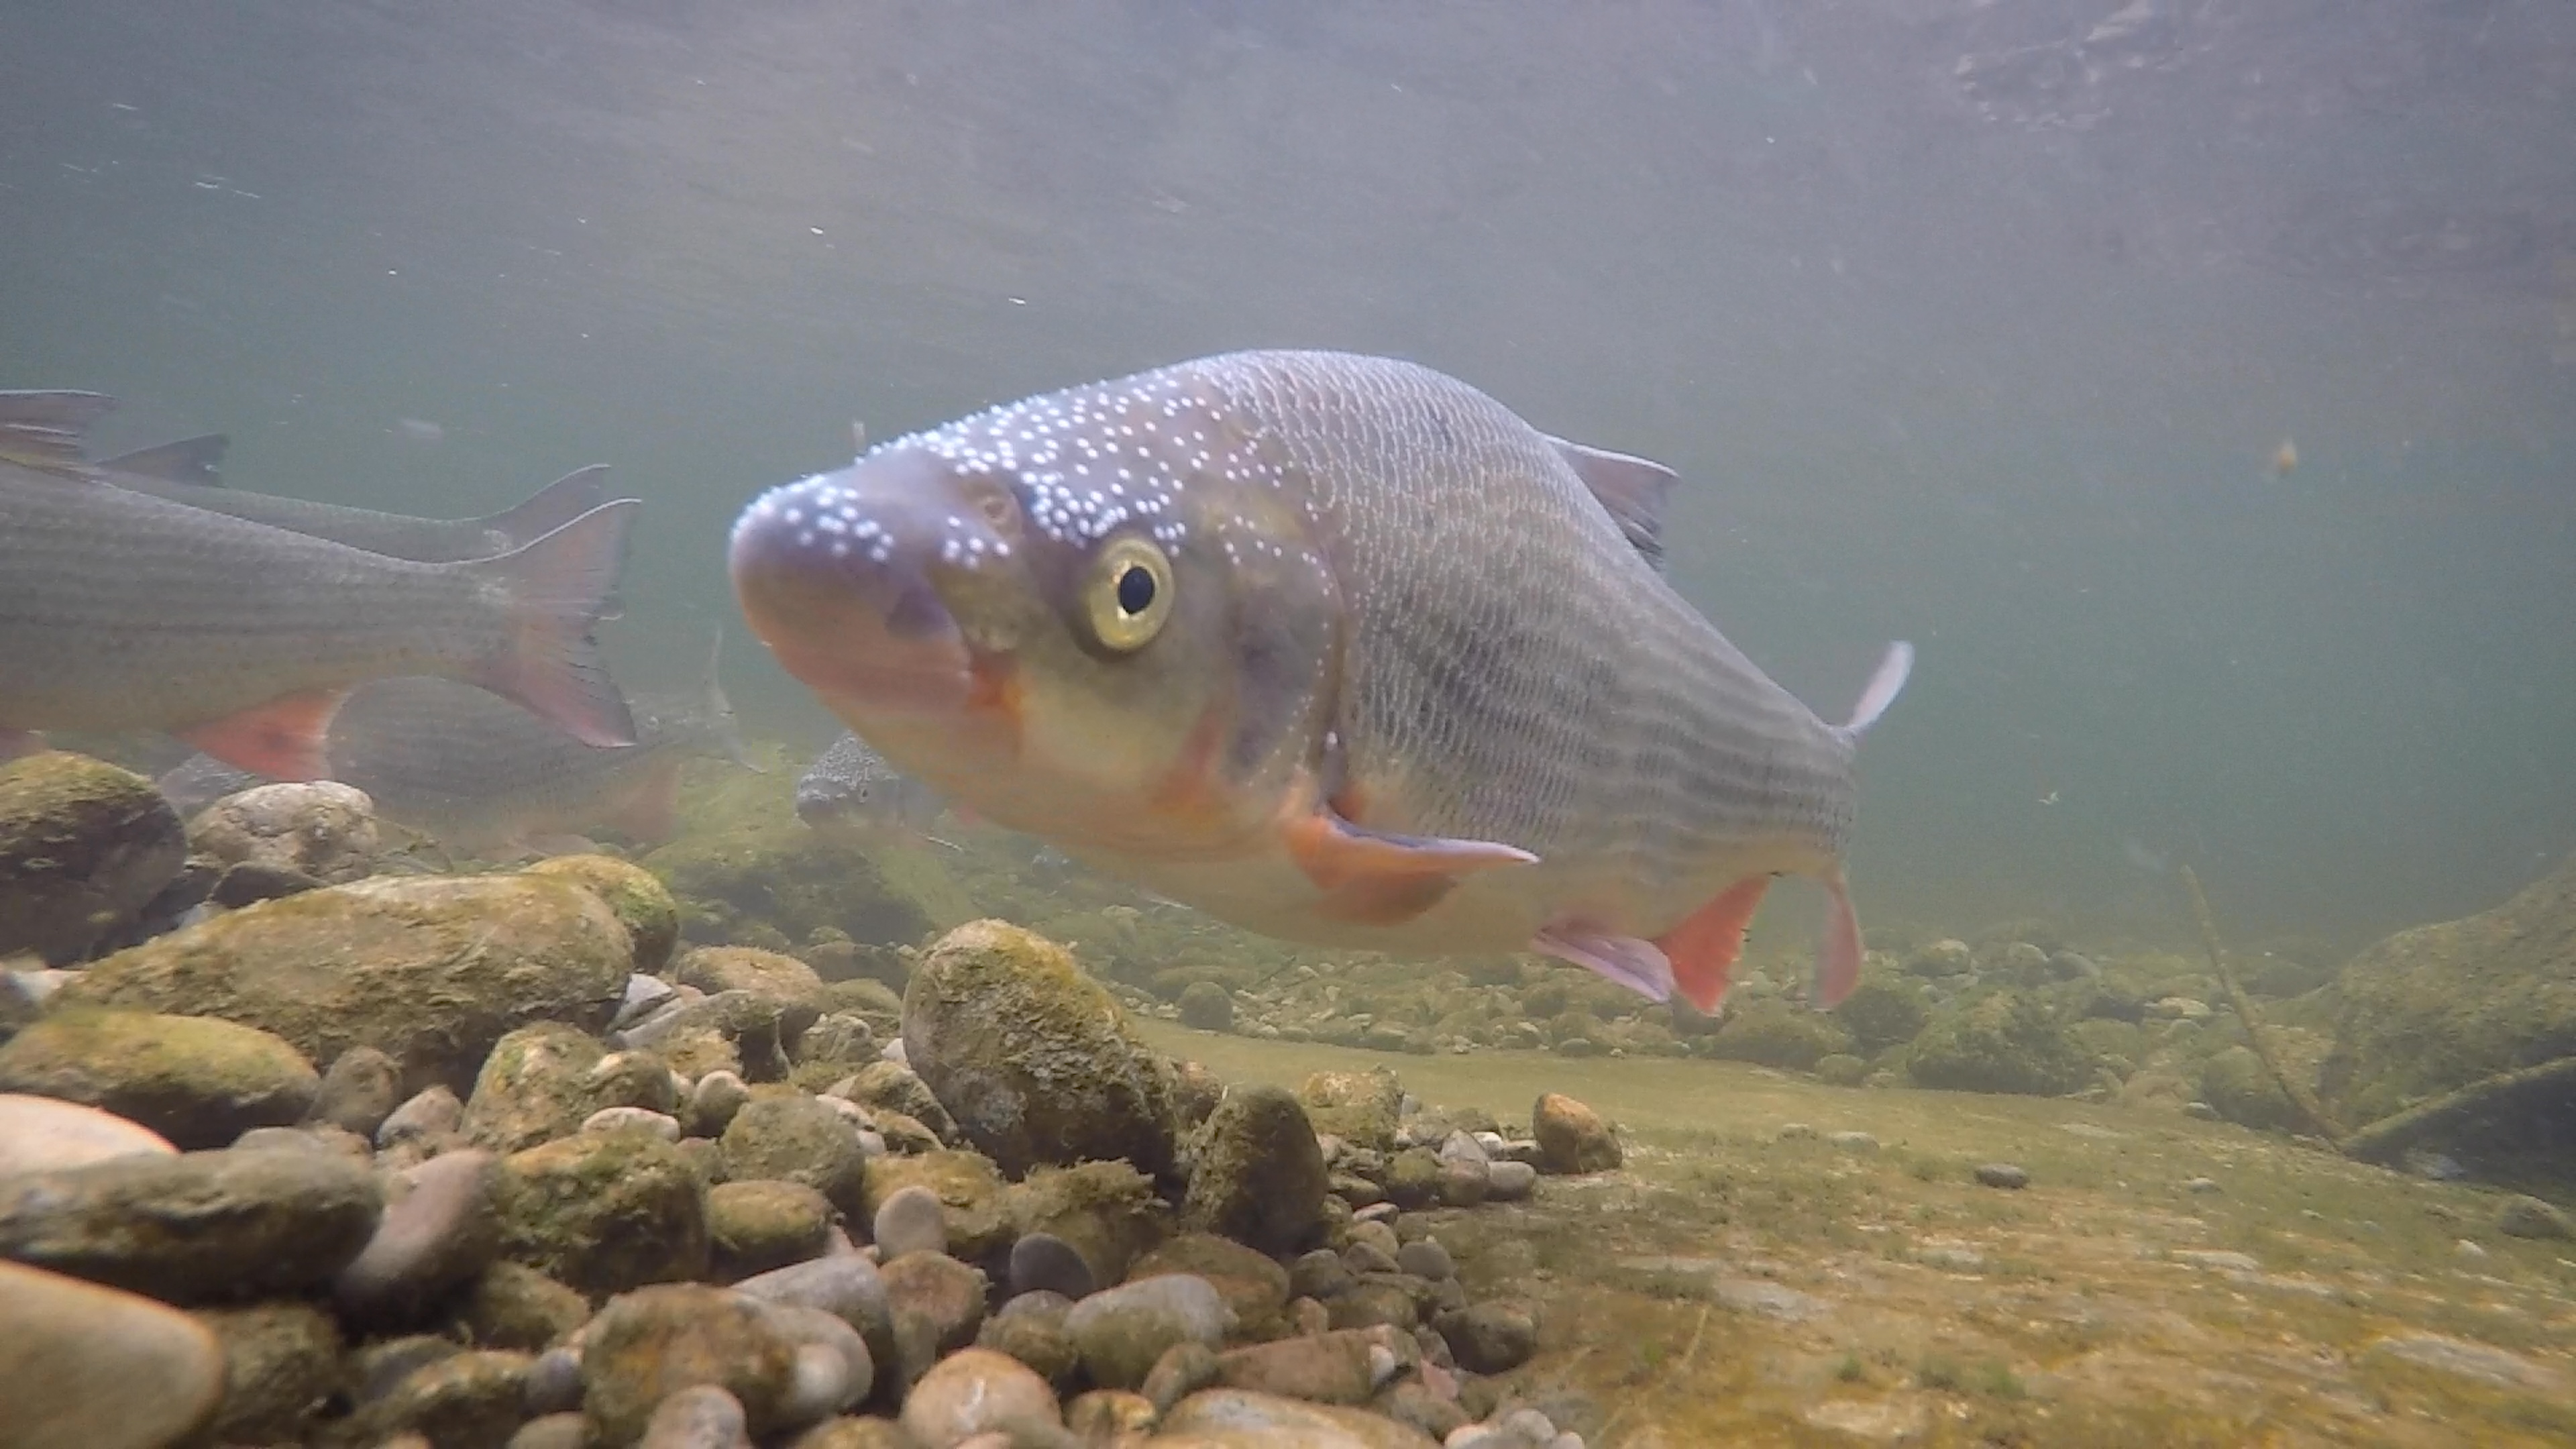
[644, 810, 932, 947]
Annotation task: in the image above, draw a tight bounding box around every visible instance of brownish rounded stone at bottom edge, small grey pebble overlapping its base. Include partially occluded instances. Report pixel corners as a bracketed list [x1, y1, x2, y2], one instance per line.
[582, 1284, 796, 1444]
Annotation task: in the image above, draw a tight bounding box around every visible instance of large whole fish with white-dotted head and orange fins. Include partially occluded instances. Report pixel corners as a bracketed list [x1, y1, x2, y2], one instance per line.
[727, 351, 1914, 1011]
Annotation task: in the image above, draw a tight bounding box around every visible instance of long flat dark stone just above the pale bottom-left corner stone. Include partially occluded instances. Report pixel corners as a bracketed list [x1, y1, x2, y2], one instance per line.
[0, 1150, 384, 1302]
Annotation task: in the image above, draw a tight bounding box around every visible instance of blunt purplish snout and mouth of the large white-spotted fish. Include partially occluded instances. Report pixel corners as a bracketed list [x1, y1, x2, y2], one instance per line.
[727, 474, 976, 714]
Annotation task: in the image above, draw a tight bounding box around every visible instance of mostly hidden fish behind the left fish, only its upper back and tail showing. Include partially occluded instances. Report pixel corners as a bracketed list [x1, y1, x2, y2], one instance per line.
[93, 433, 608, 565]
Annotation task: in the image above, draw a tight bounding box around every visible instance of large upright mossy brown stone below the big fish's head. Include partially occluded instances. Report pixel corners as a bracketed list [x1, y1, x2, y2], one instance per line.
[904, 920, 1177, 1176]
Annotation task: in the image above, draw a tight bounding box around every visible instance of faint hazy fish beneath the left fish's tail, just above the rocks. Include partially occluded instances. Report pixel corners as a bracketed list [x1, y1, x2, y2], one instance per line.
[160, 629, 760, 859]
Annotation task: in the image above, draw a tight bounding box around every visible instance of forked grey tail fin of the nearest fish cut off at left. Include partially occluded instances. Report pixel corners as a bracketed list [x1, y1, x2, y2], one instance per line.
[479, 498, 641, 748]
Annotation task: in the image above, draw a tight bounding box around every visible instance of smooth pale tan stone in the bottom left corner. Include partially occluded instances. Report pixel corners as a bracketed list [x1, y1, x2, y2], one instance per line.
[0, 1263, 224, 1449]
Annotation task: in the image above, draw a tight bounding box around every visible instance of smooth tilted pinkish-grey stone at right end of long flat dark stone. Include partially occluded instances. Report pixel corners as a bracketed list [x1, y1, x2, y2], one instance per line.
[332, 1150, 500, 1323]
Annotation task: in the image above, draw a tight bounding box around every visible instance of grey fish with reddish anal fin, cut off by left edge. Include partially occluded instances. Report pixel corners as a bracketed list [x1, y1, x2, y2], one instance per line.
[0, 392, 636, 779]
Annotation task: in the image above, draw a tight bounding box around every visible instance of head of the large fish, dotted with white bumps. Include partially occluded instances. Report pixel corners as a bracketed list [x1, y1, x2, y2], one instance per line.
[732, 374, 1342, 859]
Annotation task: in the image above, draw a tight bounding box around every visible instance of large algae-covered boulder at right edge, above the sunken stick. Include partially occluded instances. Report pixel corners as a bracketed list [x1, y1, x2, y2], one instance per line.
[2321, 856, 2576, 1124]
